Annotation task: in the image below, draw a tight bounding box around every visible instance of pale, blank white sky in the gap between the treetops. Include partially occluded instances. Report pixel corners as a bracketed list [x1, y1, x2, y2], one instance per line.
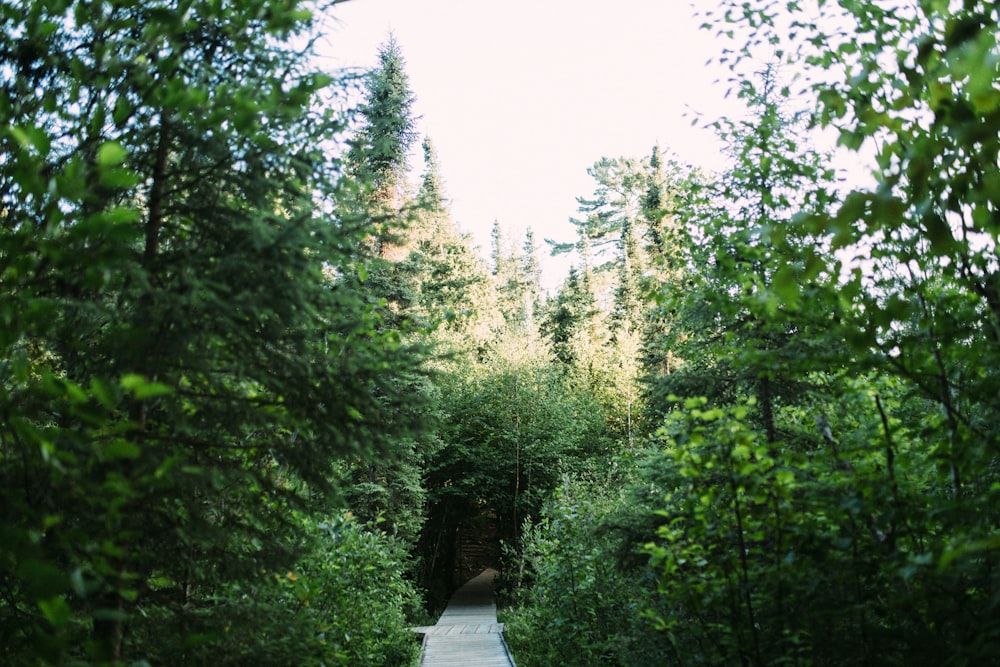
[316, 0, 735, 287]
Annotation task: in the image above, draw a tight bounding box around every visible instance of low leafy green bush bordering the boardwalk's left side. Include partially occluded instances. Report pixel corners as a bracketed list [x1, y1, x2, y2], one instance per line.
[125, 517, 421, 667]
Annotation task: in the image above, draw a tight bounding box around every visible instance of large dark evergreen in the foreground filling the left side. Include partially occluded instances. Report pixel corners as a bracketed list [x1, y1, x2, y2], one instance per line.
[0, 0, 424, 665]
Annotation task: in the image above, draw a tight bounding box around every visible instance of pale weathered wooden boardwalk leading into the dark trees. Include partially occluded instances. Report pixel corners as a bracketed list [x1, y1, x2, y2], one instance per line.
[413, 570, 514, 667]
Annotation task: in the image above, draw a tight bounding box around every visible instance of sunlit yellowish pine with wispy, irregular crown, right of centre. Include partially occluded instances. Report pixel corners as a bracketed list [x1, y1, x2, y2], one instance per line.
[545, 154, 690, 443]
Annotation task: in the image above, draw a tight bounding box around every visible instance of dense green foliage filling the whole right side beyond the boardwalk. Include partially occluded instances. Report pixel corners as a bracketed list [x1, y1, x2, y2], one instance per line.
[511, 1, 1000, 665]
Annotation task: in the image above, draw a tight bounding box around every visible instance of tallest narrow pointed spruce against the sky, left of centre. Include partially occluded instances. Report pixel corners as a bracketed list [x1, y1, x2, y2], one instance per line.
[344, 35, 443, 548]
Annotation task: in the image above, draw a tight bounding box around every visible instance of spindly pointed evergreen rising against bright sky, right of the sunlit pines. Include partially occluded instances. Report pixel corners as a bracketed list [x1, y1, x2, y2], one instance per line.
[653, 68, 833, 442]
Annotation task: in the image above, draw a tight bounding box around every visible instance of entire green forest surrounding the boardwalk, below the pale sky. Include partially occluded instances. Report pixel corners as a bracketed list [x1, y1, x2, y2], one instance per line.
[0, 0, 1000, 667]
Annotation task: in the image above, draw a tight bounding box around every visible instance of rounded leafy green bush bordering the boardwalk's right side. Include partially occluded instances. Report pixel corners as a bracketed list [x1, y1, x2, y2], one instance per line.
[505, 481, 667, 667]
